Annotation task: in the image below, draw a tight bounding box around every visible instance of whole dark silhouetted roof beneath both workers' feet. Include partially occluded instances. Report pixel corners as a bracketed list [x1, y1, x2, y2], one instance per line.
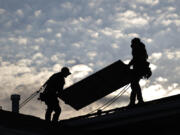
[0, 95, 180, 135]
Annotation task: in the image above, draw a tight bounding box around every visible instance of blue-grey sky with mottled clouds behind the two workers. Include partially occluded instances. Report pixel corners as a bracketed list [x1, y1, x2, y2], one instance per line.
[0, 0, 180, 119]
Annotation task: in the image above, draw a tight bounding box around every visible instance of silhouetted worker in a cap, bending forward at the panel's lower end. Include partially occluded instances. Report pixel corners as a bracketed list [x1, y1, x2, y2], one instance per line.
[40, 67, 71, 122]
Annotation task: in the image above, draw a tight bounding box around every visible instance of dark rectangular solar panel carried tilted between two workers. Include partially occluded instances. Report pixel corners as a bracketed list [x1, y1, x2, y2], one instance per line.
[60, 60, 132, 110]
